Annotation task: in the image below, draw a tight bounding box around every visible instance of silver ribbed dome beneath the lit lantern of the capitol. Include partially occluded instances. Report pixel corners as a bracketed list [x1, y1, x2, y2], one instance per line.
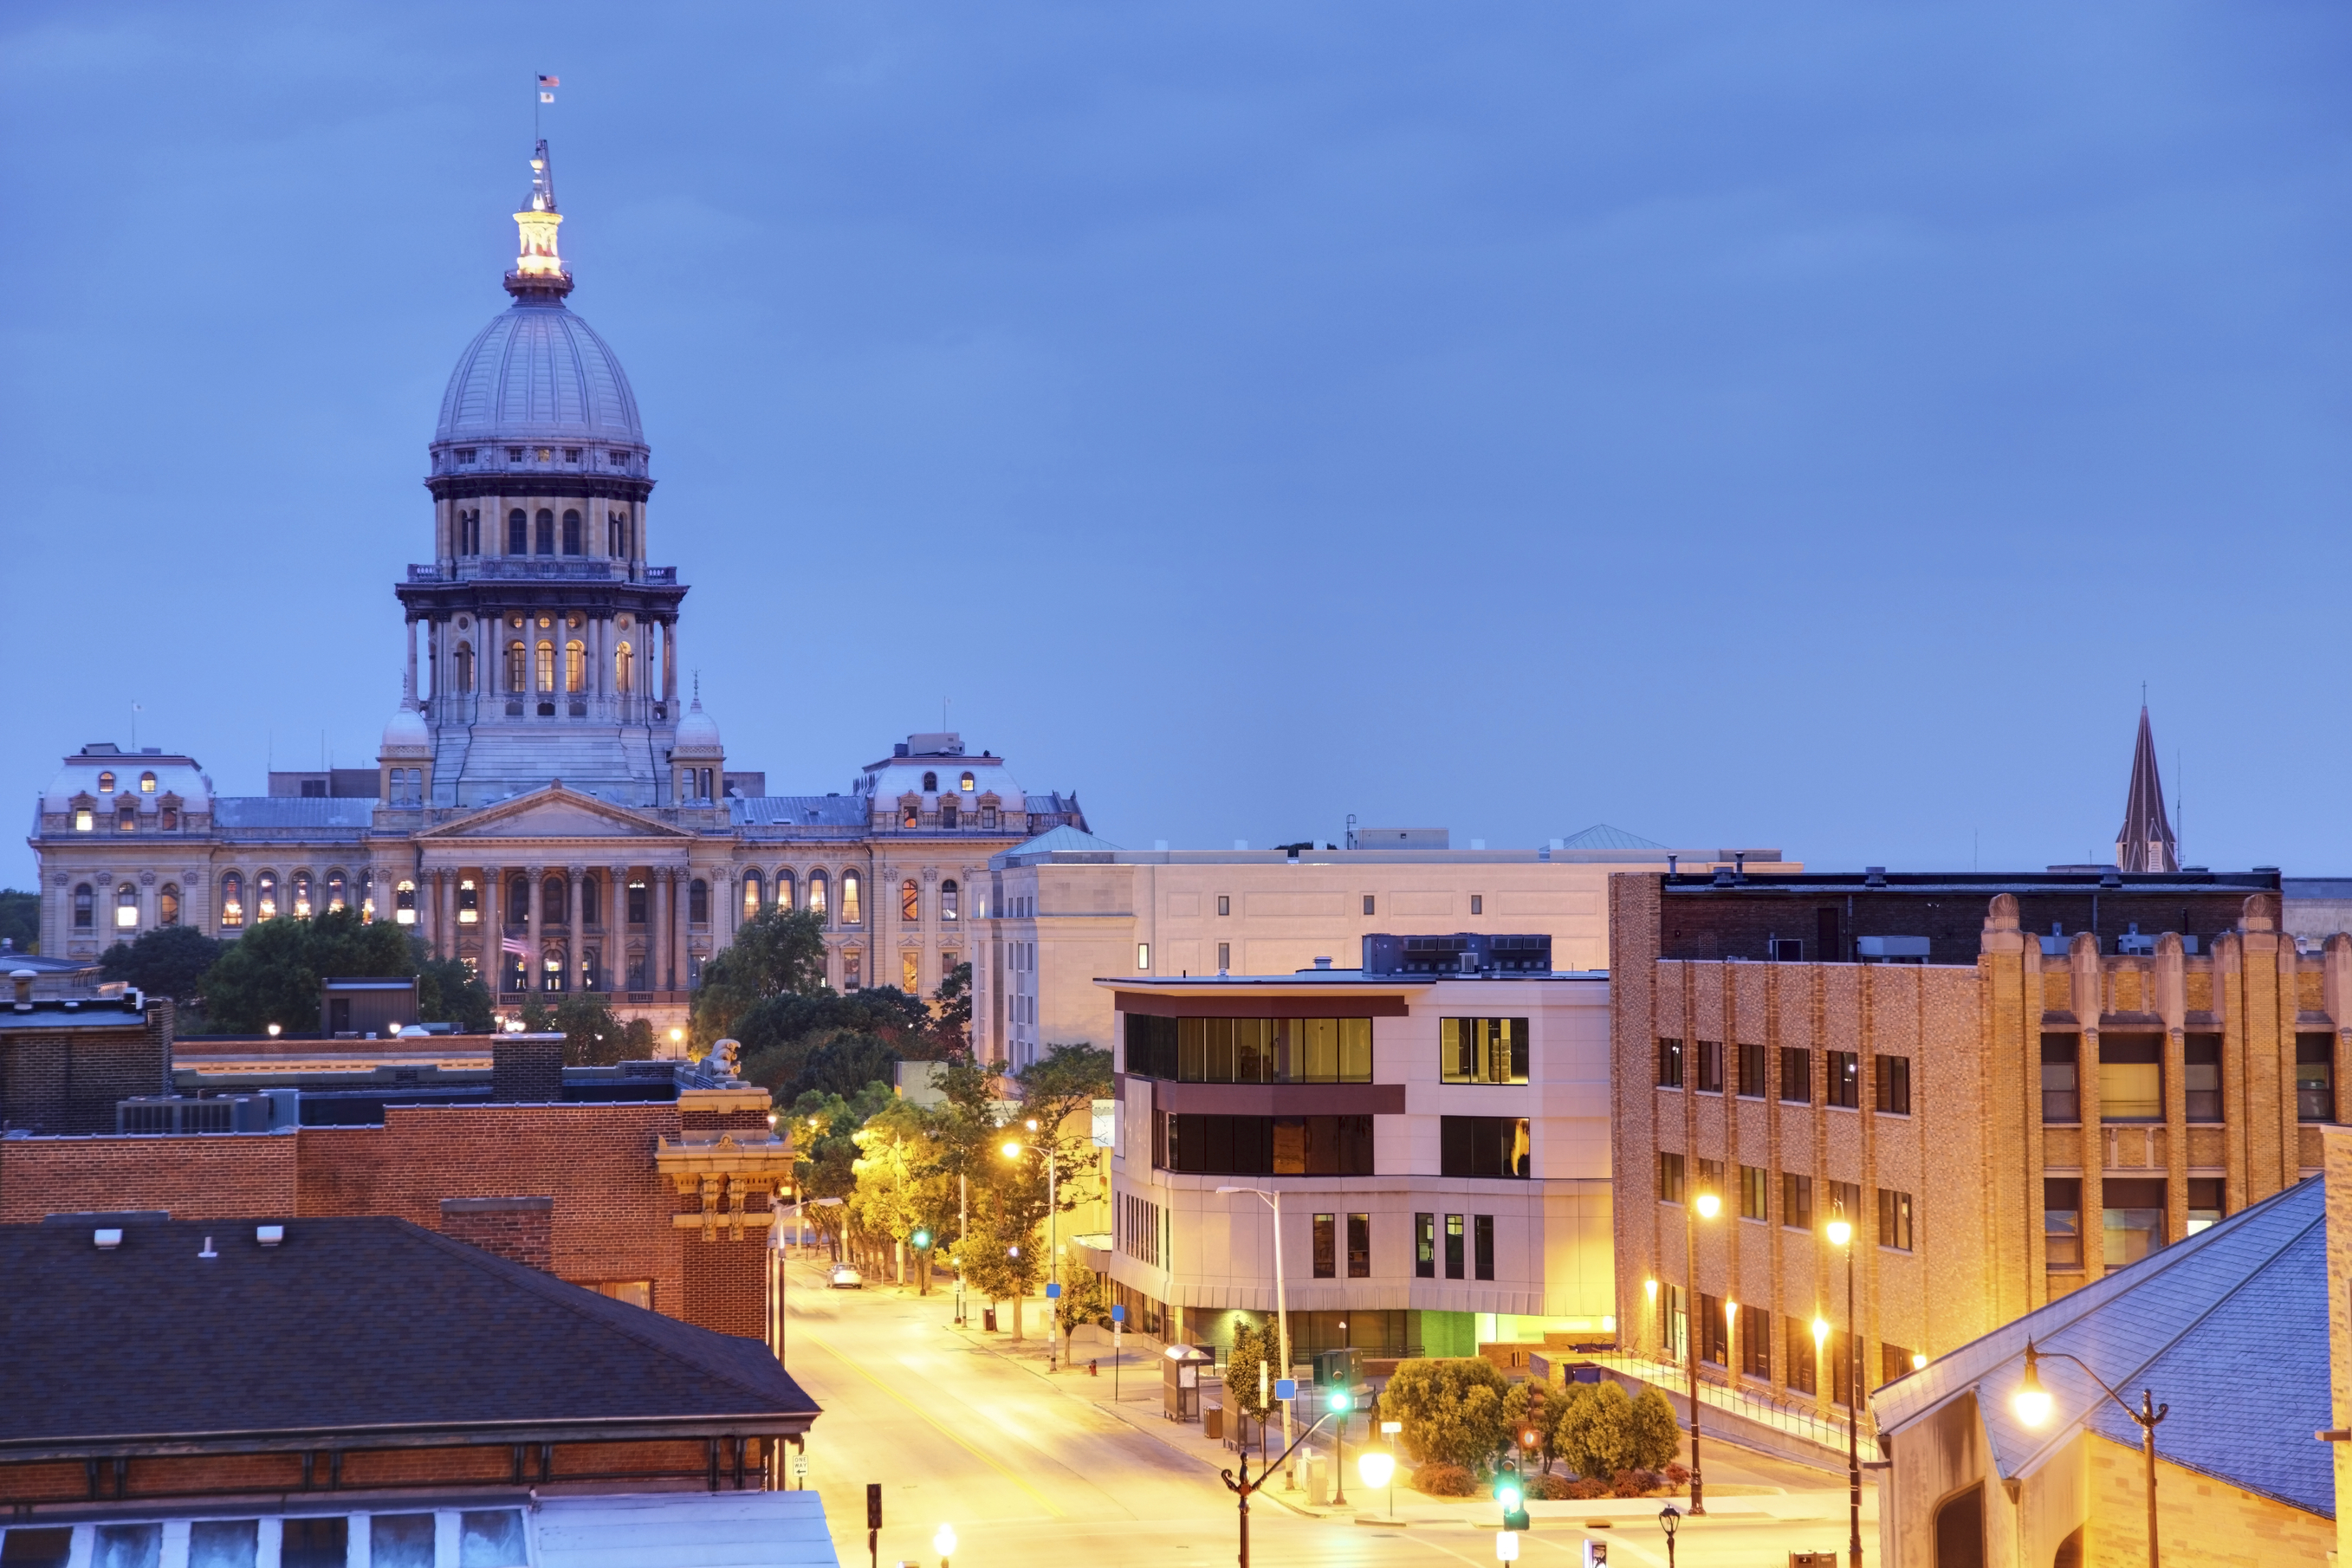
[433, 299, 645, 449]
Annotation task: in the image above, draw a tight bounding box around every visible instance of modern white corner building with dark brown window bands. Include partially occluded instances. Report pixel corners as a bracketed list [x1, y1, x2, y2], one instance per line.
[1092, 938, 1616, 1358]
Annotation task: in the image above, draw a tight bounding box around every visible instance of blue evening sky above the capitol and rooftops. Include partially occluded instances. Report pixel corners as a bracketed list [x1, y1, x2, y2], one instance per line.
[0, 0, 2352, 884]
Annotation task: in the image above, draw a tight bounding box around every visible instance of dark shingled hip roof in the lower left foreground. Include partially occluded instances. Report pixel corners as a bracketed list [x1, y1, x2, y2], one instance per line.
[0, 1218, 819, 1460]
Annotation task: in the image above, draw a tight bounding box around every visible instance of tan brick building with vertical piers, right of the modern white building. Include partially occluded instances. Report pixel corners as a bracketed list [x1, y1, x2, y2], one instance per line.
[1611, 867, 2352, 1413]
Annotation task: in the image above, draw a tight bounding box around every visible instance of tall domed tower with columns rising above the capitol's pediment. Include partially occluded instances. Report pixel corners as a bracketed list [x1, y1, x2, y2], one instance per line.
[395, 141, 687, 807]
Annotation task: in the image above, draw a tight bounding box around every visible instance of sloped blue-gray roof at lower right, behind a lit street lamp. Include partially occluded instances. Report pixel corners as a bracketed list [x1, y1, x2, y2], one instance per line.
[1869, 1178, 2336, 1519]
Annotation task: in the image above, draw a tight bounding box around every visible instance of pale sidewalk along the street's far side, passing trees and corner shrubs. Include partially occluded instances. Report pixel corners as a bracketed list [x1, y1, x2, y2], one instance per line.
[793, 1258, 1875, 1532]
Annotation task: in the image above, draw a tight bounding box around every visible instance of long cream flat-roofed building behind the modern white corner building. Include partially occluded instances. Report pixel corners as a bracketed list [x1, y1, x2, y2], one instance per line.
[971, 827, 1802, 1067]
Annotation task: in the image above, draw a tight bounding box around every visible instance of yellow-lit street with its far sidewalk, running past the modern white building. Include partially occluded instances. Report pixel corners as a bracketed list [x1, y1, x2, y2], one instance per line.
[786, 1260, 1877, 1568]
